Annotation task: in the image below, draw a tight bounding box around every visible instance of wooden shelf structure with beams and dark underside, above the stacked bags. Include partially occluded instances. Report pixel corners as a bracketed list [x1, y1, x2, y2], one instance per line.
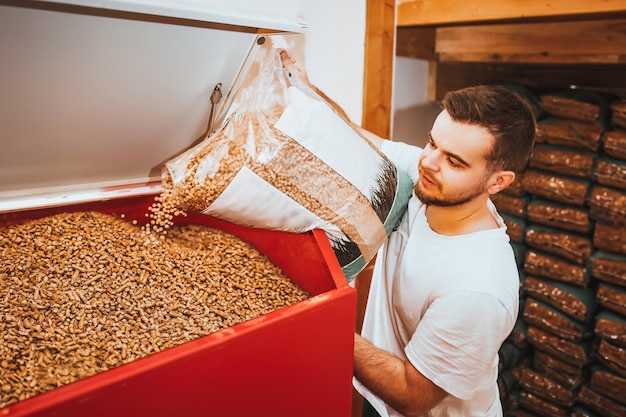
[396, 0, 626, 100]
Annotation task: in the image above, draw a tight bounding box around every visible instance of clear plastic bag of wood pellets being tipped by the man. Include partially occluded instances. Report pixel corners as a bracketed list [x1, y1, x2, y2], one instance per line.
[163, 48, 413, 280]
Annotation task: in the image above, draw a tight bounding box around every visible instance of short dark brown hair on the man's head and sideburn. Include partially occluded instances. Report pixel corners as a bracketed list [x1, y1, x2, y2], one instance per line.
[442, 85, 537, 172]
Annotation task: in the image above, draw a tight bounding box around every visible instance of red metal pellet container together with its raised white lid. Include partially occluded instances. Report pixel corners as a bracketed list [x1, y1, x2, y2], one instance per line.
[0, 0, 356, 417]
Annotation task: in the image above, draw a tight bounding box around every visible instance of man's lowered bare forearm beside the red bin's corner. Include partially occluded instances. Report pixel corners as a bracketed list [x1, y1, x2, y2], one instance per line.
[354, 334, 447, 416]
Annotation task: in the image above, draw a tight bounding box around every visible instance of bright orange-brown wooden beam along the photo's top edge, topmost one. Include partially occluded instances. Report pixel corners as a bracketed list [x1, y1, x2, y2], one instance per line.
[398, 0, 626, 26]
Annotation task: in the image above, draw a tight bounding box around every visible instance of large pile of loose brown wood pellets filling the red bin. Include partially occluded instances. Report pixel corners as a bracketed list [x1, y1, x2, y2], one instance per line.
[0, 212, 310, 408]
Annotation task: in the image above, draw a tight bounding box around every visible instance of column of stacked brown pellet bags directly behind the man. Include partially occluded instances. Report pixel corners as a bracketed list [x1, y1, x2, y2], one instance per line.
[494, 90, 620, 416]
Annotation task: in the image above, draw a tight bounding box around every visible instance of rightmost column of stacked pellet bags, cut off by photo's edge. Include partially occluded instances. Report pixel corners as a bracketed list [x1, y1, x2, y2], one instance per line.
[578, 100, 626, 417]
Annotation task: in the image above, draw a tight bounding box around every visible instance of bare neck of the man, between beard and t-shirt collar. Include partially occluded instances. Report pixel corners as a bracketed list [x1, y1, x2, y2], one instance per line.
[426, 198, 498, 236]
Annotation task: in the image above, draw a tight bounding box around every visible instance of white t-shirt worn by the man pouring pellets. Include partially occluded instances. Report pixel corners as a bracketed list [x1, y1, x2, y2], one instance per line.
[354, 141, 519, 417]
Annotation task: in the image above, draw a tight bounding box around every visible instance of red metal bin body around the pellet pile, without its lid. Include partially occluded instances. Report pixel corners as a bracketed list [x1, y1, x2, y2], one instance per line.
[0, 196, 356, 417]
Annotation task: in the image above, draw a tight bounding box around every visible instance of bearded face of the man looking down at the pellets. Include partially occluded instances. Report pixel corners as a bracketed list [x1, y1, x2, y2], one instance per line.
[414, 110, 493, 206]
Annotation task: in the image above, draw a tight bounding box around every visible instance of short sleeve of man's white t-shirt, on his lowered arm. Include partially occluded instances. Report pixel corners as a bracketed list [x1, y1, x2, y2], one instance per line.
[405, 291, 516, 400]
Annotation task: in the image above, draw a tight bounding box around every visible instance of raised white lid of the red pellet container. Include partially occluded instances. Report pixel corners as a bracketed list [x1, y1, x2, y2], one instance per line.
[0, 0, 305, 212]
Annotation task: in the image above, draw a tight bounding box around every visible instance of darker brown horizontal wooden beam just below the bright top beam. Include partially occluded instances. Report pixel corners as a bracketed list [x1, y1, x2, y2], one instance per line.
[434, 19, 626, 64]
